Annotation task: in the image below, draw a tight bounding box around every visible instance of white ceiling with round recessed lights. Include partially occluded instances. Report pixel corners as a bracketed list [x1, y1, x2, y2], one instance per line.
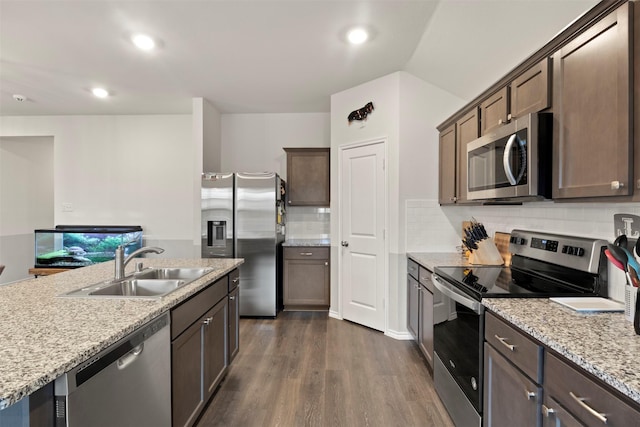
[0, 0, 597, 116]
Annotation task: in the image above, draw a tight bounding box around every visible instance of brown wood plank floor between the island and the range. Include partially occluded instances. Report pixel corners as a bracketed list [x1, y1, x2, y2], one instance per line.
[197, 312, 453, 427]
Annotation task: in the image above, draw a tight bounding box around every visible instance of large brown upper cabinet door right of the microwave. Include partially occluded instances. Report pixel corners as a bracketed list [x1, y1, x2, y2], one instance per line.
[553, 3, 633, 199]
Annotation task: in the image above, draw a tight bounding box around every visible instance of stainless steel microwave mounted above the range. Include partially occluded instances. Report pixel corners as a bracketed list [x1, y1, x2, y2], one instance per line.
[466, 113, 553, 200]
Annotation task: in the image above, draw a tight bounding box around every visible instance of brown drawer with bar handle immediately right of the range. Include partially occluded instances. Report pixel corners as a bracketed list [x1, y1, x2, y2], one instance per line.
[485, 312, 543, 384]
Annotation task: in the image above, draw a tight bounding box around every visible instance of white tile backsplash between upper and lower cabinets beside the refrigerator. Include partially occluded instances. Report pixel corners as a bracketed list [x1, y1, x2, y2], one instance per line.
[285, 206, 331, 240]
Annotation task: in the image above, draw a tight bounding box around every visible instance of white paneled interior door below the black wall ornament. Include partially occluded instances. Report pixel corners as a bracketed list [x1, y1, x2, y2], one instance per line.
[340, 142, 386, 331]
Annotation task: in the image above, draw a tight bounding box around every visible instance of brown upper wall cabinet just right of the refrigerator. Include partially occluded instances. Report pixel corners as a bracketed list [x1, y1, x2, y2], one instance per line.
[284, 148, 331, 206]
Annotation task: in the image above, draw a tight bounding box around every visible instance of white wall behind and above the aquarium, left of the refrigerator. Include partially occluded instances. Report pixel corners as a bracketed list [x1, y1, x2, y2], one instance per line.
[0, 115, 199, 257]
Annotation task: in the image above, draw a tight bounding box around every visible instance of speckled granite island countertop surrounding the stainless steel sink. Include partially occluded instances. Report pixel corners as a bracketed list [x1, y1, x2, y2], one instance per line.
[0, 258, 244, 410]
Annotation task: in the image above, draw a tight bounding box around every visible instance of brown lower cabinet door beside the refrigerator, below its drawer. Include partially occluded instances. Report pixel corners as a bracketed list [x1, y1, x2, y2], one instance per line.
[284, 255, 329, 308]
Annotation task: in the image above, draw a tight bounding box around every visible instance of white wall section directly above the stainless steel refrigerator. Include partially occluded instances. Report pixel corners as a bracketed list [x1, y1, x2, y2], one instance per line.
[221, 113, 330, 176]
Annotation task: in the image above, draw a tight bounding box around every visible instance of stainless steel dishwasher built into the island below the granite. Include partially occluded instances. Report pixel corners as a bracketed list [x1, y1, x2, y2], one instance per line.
[55, 313, 171, 427]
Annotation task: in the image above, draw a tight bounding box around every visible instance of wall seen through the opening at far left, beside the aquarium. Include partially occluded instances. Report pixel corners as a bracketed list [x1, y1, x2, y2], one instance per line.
[0, 136, 54, 283]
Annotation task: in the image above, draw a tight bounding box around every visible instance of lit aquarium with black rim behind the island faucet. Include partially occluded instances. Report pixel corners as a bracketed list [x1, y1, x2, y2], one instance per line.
[34, 225, 142, 268]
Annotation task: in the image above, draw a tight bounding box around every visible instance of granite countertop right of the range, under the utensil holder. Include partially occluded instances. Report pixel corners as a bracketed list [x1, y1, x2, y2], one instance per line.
[482, 298, 640, 403]
